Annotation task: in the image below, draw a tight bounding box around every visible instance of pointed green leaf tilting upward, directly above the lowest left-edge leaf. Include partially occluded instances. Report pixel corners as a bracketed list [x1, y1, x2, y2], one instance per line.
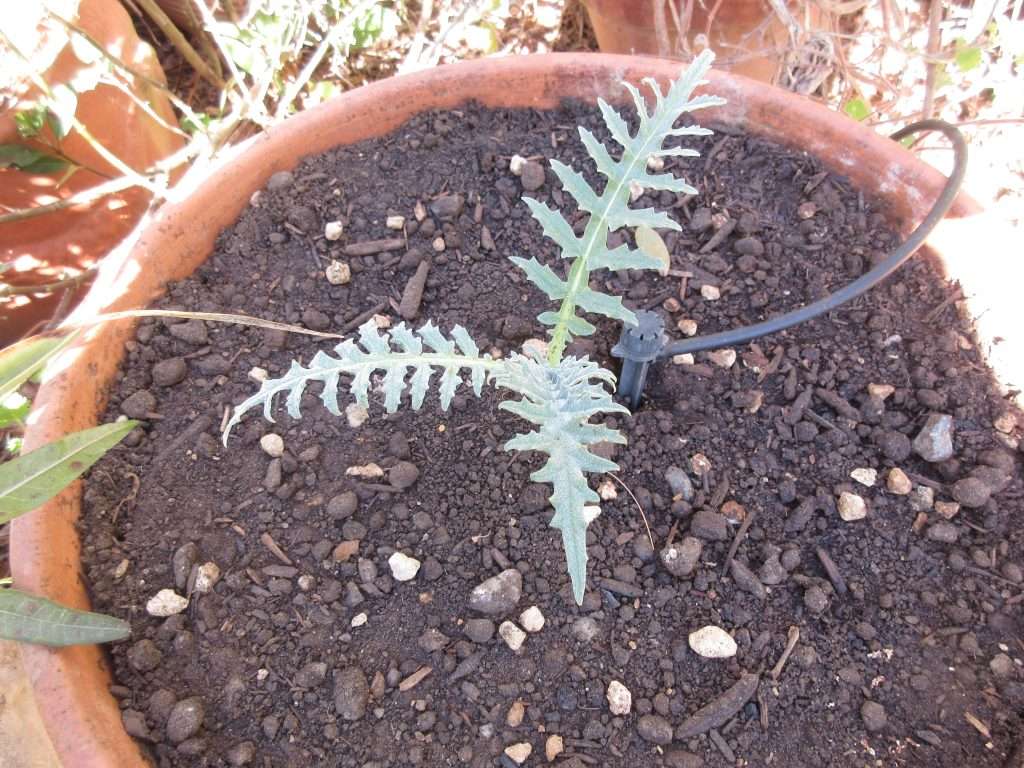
[0, 421, 138, 523]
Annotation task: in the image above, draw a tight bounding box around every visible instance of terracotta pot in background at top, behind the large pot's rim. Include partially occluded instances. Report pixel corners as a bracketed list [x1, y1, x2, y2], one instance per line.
[584, 0, 816, 83]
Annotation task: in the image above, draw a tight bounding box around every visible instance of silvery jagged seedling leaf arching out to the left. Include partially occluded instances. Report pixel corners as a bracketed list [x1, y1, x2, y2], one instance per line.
[223, 319, 501, 442]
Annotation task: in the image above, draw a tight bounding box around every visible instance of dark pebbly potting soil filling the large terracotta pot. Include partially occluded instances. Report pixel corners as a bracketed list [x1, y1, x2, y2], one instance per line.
[82, 97, 1024, 768]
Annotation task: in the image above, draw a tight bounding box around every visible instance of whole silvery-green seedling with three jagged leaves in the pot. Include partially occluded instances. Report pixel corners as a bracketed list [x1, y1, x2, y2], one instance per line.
[224, 51, 724, 603]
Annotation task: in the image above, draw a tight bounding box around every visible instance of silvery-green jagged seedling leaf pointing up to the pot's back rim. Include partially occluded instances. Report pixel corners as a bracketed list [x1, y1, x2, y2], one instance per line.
[513, 51, 724, 364]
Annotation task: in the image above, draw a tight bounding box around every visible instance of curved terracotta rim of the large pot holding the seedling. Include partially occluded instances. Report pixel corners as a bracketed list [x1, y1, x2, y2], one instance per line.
[11, 53, 1007, 768]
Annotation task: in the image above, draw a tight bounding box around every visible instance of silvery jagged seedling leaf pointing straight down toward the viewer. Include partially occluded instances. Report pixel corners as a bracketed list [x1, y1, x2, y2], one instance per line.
[495, 354, 628, 604]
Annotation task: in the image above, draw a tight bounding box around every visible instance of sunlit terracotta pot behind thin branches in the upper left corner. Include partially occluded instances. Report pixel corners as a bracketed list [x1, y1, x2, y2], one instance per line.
[0, 0, 183, 346]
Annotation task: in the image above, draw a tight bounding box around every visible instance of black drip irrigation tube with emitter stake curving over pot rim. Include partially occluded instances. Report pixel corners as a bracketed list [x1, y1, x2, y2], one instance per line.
[611, 120, 967, 409]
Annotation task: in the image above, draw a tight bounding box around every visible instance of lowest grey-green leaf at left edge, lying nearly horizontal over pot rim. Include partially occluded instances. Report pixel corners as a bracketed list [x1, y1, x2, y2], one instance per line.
[0, 588, 131, 646]
